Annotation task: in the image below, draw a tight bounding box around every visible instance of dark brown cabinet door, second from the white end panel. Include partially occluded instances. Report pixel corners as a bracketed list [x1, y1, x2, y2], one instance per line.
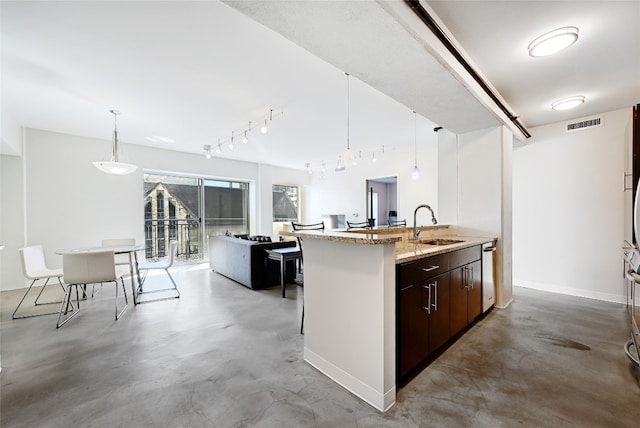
[428, 272, 451, 353]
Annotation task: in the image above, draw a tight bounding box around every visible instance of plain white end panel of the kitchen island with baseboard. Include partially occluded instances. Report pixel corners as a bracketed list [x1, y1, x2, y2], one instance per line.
[303, 238, 396, 411]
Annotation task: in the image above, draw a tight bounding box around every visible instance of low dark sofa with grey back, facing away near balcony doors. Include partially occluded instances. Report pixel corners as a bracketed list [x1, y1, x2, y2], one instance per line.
[209, 235, 296, 290]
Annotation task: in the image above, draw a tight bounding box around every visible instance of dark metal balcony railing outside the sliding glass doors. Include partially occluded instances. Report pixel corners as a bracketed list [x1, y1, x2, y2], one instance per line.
[144, 217, 249, 260]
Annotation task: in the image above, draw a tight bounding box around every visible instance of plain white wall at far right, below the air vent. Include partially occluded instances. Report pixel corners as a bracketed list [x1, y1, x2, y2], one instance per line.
[513, 108, 631, 302]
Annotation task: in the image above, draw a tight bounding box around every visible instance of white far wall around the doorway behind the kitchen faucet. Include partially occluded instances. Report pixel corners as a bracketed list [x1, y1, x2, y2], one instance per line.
[302, 131, 438, 225]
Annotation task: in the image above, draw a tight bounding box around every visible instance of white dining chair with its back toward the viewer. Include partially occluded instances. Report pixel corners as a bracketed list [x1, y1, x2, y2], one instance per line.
[56, 250, 129, 328]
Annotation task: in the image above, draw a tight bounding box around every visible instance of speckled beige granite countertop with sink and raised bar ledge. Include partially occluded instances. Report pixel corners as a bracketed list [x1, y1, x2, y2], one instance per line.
[280, 225, 496, 264]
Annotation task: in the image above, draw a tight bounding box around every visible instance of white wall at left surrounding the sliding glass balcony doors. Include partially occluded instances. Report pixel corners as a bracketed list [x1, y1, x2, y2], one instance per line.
[0, 129, 309, 290]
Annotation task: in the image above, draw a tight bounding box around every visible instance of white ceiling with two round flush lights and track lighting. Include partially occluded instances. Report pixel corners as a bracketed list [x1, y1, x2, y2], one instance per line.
[0, 1, 640, 168]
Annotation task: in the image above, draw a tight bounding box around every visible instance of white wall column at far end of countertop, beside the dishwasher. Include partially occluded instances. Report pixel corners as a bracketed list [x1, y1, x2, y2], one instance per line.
[438, 126, 513, 307]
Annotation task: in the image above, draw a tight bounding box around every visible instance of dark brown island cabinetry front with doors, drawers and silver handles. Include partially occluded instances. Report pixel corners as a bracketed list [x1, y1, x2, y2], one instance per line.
[396, 246, 482, 379]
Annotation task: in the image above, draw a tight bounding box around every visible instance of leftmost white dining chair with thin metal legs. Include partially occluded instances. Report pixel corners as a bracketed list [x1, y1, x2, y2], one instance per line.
[11, 245, 65, 319]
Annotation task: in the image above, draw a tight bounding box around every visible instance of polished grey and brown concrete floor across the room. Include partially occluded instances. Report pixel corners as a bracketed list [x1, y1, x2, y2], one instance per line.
[0, 265, 640, 428]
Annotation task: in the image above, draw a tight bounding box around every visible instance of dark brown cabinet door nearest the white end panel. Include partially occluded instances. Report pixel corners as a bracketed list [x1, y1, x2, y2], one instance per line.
[398, 284, 429, 377]
